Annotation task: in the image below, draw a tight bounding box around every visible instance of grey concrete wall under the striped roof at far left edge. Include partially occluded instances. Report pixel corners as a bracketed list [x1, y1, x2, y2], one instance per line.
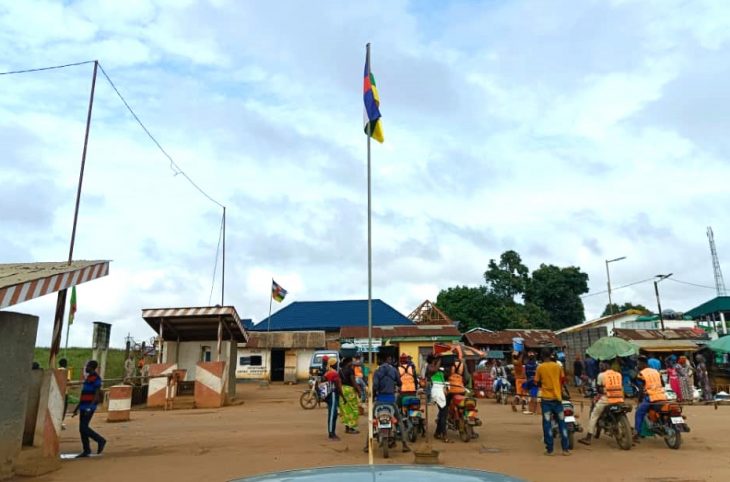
[0, 311, 38, 480]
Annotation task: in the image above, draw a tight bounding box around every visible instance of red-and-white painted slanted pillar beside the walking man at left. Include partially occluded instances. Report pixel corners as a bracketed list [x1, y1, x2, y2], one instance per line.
[33, 369, 66, 457]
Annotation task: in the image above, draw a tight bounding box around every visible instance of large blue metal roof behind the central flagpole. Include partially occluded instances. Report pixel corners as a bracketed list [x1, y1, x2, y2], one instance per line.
[246, 300, 413, 331]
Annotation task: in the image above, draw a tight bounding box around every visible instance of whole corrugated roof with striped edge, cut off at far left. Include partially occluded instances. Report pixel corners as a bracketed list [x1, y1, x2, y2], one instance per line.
[0, 260, 109, 308]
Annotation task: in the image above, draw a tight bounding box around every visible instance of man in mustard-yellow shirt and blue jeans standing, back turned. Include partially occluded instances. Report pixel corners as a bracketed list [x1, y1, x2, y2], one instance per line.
[535, 349, 570, 455]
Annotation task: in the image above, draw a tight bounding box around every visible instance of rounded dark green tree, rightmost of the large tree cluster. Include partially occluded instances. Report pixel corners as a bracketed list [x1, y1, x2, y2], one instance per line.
[525, 264, 588, 330]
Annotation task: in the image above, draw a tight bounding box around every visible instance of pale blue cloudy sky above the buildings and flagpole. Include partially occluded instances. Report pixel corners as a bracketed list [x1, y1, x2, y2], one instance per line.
[0, 0, 730, 346]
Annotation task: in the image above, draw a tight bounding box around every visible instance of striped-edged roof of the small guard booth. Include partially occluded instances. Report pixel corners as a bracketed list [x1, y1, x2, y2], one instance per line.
[142, 306, 248, 342]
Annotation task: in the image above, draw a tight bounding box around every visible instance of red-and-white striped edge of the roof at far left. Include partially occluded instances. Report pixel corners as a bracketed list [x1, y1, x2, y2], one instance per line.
[0, 261, 109, 308]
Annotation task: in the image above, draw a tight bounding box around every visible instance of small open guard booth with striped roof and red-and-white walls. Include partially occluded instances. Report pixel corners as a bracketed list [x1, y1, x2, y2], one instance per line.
[142, 306, 248, 408]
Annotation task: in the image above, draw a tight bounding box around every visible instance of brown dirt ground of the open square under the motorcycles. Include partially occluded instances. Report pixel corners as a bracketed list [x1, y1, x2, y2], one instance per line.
[35, 384, 730, 482]
